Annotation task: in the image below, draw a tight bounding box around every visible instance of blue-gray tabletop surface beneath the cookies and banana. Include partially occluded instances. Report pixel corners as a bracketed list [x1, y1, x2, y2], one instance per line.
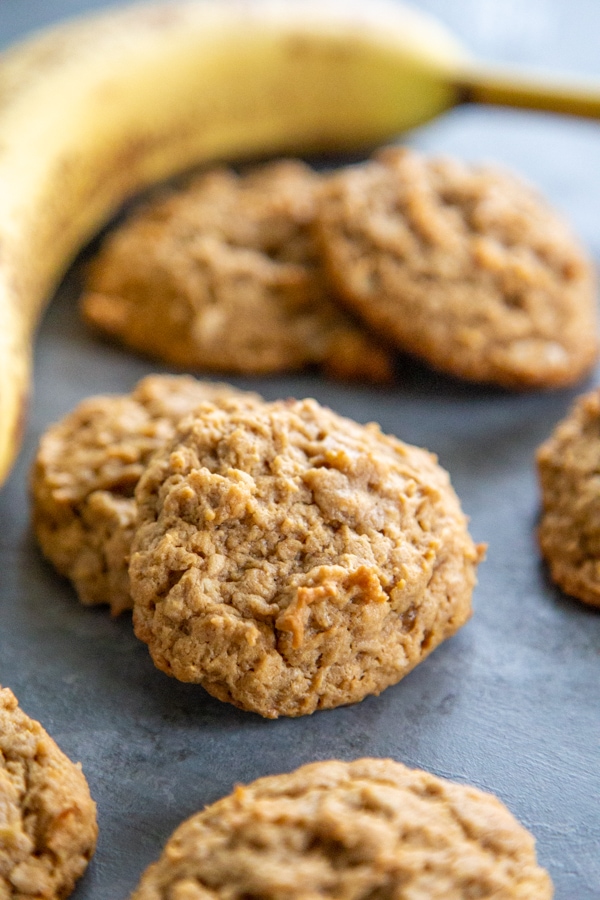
[0, 0, 600, 900]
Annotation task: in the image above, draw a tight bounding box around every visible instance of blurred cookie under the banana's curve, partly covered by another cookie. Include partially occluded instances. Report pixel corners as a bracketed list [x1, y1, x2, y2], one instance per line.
[82, 161, 392, 381]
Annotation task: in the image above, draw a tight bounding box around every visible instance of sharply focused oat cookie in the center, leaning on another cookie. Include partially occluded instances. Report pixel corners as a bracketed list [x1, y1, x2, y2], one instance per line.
[129, 400, 481, 718]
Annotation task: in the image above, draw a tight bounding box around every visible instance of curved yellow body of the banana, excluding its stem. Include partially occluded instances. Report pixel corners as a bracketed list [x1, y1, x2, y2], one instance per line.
[0, 0, 462, 483]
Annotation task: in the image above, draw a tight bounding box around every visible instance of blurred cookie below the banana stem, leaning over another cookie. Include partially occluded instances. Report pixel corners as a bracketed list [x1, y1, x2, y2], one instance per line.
[317, 148, 598, 389]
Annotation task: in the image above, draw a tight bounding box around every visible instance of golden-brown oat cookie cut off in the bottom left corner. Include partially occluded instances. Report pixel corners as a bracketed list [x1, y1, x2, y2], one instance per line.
[0, 688, 98, 900]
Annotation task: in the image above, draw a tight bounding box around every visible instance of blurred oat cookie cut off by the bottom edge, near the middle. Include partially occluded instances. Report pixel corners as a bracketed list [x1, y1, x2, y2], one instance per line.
[131, 759, 552, 900]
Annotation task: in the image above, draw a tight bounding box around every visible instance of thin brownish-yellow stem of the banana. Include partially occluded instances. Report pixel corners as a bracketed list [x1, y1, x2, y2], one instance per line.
[455, 66, 600, 119]
